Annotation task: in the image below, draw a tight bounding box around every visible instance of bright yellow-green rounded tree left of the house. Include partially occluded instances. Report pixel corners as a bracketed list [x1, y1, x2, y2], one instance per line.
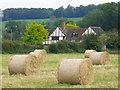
[22, 23, 48, 45]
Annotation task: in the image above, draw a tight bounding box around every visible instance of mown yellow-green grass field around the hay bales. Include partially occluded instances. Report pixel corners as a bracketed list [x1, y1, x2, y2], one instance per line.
[2, 53, 118, 88]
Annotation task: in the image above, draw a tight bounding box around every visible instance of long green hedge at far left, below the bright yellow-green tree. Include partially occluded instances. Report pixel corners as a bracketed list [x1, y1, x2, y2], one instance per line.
[2, 39, 43, 54]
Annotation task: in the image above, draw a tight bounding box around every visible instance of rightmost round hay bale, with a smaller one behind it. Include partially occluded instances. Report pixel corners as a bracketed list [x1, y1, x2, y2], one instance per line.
[90, 52, 110, 65]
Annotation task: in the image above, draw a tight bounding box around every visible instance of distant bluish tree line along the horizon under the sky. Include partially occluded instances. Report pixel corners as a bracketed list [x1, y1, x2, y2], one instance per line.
[2, 4, 101, 21]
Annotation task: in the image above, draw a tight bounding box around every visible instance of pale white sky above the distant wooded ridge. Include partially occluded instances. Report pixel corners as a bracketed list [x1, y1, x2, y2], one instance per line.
[0, 0, 120, 10]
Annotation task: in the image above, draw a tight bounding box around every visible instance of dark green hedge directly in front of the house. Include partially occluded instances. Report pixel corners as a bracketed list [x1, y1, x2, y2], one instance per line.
[46, 41, 86, 53]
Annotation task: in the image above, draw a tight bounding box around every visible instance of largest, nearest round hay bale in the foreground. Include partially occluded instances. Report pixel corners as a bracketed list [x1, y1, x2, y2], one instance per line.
[57, 58, 93, 84]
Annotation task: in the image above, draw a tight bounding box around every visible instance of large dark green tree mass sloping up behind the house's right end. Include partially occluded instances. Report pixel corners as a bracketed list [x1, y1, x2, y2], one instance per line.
[77, 2, 119, 31]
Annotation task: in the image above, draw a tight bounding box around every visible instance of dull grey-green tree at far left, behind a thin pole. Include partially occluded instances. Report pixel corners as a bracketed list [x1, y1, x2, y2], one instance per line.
[3, 20, 26, 40]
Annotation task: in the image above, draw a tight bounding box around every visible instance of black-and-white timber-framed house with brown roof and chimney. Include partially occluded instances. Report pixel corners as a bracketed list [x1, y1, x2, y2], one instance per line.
[43, 23, 104, 44]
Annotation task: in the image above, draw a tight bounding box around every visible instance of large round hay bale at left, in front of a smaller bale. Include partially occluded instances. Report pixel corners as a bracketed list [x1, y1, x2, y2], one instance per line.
[8, 54, 39, 75]
